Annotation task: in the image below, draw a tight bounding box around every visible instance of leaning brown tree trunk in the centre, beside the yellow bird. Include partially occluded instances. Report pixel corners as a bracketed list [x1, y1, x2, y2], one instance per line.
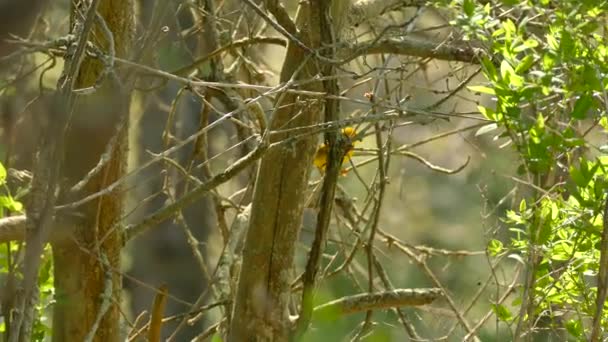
[228, 1, 342, 342]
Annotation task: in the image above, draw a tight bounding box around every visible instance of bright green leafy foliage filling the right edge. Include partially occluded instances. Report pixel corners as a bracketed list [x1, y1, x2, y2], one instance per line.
[448, 0, 608, 340]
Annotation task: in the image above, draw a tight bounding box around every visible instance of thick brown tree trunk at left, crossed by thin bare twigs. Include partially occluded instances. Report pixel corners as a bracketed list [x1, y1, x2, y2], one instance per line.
[52, 0, 134, 341]
